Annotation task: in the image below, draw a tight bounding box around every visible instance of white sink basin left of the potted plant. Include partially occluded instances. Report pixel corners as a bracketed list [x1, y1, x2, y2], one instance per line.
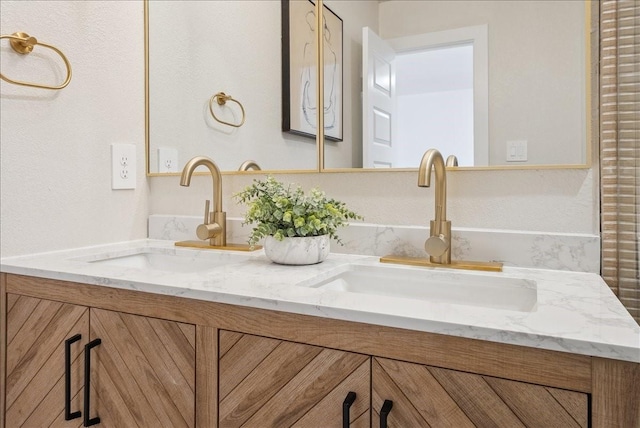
[76, 248, 251, 272]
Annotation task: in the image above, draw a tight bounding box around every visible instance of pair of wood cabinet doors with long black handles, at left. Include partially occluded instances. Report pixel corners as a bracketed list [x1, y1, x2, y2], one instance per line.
[6, 294, 195, 427]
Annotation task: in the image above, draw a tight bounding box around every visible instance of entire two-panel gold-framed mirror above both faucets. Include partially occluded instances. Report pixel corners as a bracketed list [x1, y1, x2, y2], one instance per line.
[145, 0, 592, 175]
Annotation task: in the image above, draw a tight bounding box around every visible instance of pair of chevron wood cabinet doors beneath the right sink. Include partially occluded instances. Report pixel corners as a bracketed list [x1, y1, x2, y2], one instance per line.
[218, 331, 589, 428]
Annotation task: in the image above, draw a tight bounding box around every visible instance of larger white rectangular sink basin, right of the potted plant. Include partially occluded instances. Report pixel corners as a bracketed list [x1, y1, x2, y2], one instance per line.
[299, 265, 537, 312]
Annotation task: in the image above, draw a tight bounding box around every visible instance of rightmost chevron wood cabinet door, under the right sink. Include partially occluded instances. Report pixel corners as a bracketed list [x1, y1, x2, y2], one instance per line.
[372, 358, 589, 428]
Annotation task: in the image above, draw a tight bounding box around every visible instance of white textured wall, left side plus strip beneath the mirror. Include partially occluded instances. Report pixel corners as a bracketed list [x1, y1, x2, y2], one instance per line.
[0, 0, 598, 257]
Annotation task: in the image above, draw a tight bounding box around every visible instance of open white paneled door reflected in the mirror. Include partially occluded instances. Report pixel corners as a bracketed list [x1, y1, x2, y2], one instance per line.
[362, 27, 396, 168]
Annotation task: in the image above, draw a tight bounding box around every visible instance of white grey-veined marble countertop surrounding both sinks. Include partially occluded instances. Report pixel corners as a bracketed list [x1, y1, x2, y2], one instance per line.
[0, 239, 640, 363]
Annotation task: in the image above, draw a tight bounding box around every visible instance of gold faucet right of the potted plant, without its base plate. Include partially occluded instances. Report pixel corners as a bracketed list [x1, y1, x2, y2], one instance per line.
[418, 149, 451, 265]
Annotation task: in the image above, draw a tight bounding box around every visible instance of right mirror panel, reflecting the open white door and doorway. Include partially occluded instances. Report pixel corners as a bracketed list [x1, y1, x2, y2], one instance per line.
[324, 0, 591, 170]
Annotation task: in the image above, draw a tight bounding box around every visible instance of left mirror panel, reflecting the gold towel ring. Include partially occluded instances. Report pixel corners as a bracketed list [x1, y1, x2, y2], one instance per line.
[145, 0, 318, 175]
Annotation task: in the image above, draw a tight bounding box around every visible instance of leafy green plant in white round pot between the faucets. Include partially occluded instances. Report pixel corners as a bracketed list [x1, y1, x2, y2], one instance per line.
[233, 176, 362, 265]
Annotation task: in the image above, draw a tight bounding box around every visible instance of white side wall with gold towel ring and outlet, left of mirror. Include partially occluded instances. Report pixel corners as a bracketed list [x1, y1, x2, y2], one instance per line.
[0, 0, 149, 257]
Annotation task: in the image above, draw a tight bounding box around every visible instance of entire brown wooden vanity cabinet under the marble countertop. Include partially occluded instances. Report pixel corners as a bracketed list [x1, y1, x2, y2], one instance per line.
[0, 273, 640, 428]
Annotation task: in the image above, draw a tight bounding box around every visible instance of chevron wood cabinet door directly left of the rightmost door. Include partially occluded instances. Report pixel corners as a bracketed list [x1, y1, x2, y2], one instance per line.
[218, 331, 371, 428]
